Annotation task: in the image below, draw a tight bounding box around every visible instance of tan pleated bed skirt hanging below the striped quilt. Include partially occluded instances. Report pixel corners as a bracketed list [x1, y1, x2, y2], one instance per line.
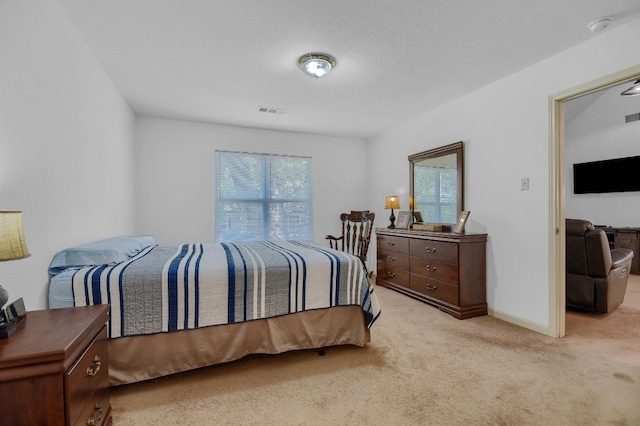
[109, 306, 370, 386]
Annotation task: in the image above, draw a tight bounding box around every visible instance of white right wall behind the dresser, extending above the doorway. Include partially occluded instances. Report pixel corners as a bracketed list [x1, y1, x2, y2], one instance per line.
[367, 20, 640, 332]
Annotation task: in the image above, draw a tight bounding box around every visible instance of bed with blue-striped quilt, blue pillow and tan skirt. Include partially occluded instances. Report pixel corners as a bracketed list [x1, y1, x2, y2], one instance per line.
[49, 236, 380, 385]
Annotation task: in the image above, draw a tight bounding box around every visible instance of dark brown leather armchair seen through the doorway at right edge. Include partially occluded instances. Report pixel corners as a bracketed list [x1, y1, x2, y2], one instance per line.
[566, 219, 633, 313]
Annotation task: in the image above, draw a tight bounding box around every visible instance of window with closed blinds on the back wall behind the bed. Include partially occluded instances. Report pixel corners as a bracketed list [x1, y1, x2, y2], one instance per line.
[216, 151, 313, 242]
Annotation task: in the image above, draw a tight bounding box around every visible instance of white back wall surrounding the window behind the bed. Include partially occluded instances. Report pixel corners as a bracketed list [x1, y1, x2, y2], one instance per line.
[135, 118, 364, 250]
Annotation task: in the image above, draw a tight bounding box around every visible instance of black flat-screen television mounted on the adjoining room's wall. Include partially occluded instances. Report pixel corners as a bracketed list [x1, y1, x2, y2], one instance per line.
[573, 156, 640, 194]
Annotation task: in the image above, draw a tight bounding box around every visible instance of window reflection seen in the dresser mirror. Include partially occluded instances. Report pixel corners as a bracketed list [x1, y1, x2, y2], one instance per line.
[413, 166, 458, 223]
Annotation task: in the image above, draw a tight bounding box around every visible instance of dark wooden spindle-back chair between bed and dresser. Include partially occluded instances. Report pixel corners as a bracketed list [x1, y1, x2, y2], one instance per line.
[326, 210, 376, 270]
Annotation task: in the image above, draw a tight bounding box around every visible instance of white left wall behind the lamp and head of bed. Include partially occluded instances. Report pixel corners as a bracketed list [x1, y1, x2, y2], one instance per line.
[0, 0, 134, 310]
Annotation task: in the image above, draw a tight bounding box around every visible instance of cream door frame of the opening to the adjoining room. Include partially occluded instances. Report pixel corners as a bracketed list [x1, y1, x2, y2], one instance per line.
[549, 65, 640, 337]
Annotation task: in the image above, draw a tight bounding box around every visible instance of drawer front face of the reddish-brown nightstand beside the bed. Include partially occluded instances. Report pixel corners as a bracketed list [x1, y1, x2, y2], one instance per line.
[65, 327, 109, 425]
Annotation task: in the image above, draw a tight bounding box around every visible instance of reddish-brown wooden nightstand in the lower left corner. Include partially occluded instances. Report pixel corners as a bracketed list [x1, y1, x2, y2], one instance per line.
[0, 305, 111, 426]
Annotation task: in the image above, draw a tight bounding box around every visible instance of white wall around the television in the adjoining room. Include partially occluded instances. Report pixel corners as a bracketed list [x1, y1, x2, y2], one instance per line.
[565, 83, 640, 227]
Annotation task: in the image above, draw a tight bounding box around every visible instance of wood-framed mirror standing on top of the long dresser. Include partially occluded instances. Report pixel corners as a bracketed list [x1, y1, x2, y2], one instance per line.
[409, 142, 464, 225]
